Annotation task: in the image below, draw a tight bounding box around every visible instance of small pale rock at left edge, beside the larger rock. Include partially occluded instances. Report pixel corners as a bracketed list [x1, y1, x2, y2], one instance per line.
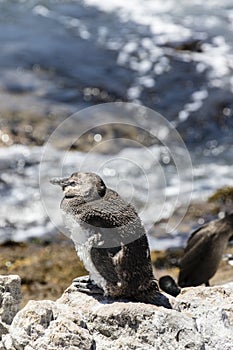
[0, 275, 21, 339]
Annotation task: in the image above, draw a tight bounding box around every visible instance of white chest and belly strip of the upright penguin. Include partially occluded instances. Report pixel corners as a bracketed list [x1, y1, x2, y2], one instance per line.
[64, 214, 106, 290]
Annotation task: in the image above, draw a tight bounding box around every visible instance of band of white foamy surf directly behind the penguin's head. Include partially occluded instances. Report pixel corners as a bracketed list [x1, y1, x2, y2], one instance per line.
[0, 140, 233, 248]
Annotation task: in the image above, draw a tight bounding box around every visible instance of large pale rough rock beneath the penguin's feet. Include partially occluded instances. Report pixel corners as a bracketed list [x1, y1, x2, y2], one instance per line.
[0, 283, 233, 350]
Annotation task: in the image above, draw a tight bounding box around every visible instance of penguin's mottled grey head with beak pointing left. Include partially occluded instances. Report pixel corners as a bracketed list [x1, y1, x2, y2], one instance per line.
[50, 172, 106, 202]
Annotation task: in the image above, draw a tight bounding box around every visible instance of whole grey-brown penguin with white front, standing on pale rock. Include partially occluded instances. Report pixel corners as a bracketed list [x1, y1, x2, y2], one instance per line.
[51, 173, 169, 305]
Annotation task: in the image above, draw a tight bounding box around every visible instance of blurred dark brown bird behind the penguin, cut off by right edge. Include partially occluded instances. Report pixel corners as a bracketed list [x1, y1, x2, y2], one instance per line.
[178, 214, 233, 287]
